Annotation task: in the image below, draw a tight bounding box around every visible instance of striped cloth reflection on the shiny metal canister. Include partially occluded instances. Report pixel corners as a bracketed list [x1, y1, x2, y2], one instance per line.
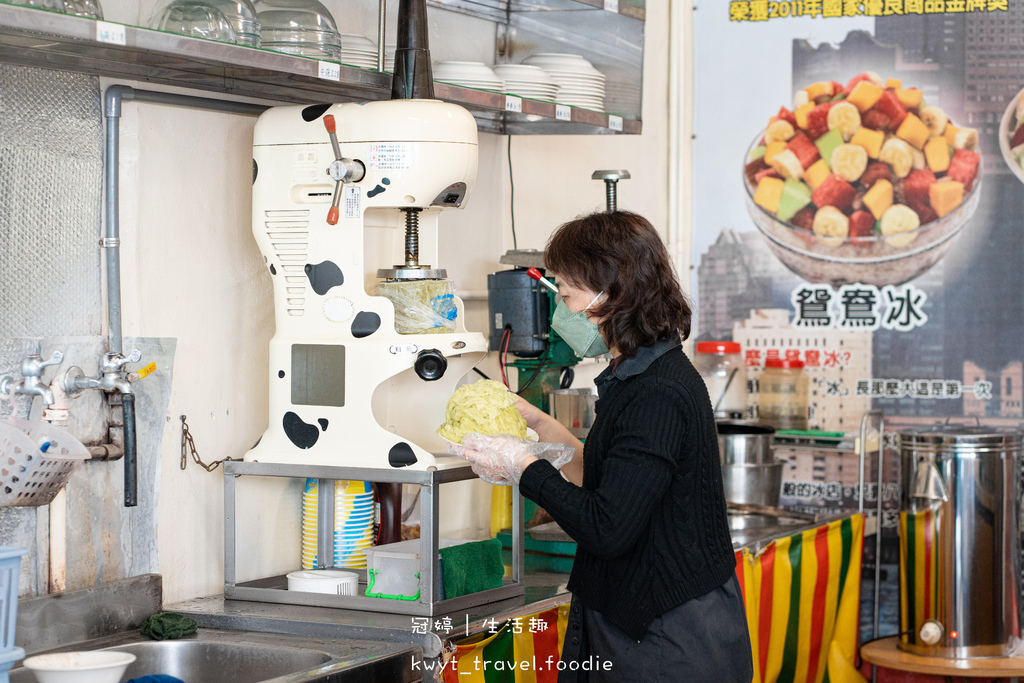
[899, 510, 942, 633]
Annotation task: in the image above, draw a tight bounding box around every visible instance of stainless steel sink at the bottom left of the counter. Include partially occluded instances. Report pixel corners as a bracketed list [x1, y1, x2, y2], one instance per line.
[10, 629, 422, 683]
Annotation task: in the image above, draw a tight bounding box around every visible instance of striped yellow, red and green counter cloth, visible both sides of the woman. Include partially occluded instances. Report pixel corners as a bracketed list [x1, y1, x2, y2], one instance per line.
[443, 515, 860, 683]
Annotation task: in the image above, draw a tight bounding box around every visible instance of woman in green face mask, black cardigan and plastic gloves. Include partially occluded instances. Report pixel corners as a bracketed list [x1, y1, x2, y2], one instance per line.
[451, 211, 753, 683]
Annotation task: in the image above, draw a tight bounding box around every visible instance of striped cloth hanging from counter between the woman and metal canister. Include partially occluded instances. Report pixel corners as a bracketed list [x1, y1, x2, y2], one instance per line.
[736, 515, 864, 683]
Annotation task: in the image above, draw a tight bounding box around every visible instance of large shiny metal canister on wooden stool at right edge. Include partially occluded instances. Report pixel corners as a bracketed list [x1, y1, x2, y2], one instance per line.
[899, 425, 1022, 658]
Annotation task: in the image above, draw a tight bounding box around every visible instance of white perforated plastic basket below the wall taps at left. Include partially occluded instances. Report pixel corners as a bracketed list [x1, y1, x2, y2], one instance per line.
[0, 420, 89, 507]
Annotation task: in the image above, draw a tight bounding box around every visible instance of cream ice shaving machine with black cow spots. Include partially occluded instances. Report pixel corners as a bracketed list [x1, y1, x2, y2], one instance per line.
[246, 99, 487, 470]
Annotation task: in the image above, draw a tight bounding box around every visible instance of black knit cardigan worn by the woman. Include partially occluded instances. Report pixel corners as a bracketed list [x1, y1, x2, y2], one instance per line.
[519, 342, 735, 640]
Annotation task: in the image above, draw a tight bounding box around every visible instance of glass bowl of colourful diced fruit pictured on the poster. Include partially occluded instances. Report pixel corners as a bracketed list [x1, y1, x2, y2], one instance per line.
[743, 72, 981, 287]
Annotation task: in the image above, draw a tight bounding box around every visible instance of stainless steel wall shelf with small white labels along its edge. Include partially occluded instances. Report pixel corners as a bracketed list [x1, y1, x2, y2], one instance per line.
[0, 3, 641, 134]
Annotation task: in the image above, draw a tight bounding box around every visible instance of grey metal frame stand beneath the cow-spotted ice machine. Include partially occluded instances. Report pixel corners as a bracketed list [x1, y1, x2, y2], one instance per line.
[224, 462, 525, 616]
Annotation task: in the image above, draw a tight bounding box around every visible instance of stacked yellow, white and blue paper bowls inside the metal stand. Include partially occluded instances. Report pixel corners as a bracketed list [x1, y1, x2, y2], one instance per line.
[301, 479, 375, 569]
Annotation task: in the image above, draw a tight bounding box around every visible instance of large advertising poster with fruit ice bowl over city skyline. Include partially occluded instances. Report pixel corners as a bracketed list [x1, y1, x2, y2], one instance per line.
[691, 0, 1024, 635]
